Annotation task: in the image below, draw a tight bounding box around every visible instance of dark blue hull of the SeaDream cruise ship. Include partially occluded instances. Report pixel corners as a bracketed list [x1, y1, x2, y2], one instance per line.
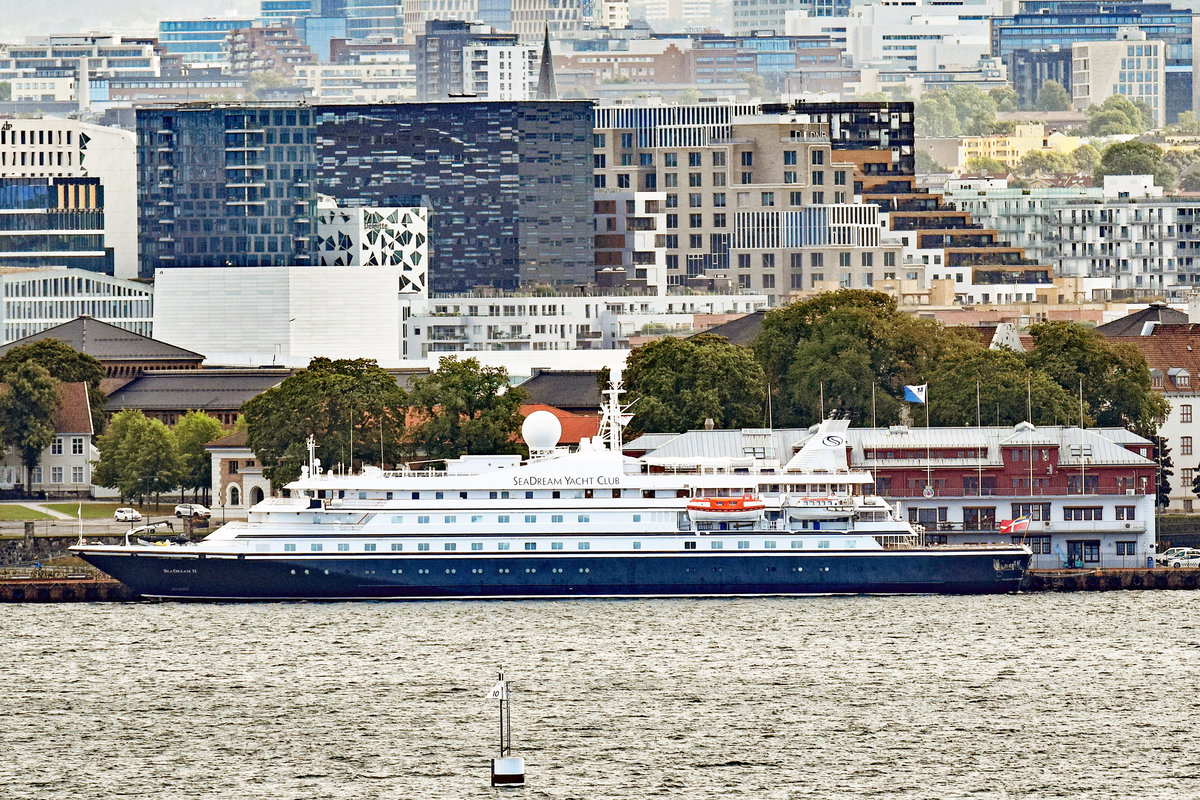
[76, 547, 1030, 600]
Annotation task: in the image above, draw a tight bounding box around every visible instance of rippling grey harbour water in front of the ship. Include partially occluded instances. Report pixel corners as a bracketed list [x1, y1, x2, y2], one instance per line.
[0, 591, 1200, 800]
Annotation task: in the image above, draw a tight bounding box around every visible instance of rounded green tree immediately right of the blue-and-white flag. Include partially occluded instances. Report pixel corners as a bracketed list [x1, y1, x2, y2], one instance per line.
[929, 347, 1079, 426]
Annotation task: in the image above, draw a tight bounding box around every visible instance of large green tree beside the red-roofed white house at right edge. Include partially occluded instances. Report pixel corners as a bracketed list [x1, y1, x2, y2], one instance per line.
[1028, 323, 1169, 435]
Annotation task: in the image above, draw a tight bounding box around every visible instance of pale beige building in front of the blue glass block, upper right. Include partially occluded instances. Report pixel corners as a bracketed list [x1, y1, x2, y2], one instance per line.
[1070, 28, 1166, 127]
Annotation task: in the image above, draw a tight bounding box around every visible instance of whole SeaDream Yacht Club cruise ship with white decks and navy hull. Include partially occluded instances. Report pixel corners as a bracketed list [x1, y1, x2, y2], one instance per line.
[72, 386, 1031, 601]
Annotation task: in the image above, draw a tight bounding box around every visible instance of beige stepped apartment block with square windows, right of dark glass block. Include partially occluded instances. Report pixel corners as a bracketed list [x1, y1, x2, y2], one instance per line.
[594, 113, 905, 305]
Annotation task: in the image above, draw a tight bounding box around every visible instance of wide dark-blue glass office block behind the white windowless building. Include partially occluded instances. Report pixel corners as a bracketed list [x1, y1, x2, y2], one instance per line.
[137, 101, 595, 291]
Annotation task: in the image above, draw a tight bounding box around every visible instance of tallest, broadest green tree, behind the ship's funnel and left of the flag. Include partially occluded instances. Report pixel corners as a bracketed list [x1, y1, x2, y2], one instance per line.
[751, 289, 964, 426]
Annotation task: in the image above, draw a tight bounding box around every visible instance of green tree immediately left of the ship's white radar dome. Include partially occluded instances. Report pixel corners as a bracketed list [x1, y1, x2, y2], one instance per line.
[408, 356, 526, 461]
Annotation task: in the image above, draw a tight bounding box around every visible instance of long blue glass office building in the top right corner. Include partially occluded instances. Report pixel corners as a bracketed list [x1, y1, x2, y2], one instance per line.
[991, 0, 1194, 122]
